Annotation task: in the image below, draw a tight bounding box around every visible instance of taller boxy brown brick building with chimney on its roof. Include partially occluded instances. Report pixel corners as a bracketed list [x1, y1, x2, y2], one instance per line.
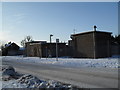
[69, 30, 111, 58]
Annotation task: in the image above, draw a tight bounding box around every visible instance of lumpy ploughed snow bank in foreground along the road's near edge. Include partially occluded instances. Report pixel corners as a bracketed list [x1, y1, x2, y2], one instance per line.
[0, 65, 73, 90]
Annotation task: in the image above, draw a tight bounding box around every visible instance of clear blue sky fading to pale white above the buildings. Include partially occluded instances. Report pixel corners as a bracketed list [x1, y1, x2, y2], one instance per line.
[0, 2, 118, 44]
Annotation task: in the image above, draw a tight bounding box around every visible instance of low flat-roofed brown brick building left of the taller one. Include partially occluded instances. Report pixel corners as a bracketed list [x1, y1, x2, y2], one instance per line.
[26, 41, 67, 57]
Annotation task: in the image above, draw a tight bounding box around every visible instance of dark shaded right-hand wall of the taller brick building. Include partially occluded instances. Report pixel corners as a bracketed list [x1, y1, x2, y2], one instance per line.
[95, 33, 111, 57]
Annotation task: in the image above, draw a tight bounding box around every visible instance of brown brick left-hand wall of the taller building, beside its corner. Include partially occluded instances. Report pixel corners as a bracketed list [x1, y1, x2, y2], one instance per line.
[73, 34, 94, 57]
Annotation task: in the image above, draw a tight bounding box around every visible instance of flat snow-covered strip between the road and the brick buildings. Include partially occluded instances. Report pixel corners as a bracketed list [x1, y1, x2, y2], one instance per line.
[2, 56, 120, 68]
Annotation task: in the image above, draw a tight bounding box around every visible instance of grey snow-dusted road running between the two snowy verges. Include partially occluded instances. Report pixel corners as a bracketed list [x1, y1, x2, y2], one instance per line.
[2, 57, 118, 88]
